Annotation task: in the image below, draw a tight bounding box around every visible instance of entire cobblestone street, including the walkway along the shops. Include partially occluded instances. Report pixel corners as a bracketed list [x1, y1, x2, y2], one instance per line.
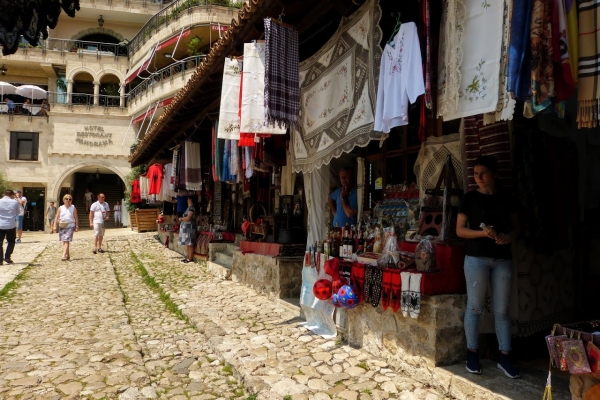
[0, 234, 444, 400]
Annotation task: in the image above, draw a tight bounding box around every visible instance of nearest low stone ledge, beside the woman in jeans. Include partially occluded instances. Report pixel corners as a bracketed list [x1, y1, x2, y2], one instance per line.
[347, 295, 466, 371]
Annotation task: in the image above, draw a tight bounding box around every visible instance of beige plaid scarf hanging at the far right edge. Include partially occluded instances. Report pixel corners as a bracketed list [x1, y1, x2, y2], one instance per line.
[577, 1, 600, 128]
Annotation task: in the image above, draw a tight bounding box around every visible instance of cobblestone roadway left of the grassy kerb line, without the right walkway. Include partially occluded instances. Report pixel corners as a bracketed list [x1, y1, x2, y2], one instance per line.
[0, 241, 245, 399]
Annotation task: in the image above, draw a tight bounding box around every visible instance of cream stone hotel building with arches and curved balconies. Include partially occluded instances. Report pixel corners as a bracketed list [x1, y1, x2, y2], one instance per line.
[0, 0, 237, 230]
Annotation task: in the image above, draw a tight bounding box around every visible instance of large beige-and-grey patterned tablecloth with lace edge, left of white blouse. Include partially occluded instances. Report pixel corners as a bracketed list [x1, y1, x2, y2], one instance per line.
[292, 0, 382, 172]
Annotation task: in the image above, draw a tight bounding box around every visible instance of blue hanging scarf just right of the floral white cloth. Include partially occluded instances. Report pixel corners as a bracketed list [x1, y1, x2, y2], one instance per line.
[507, 0, 533, 101]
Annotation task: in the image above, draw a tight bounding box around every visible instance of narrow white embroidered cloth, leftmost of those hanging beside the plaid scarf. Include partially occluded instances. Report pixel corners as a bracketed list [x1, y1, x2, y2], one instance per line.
[217, 58, 242, 140]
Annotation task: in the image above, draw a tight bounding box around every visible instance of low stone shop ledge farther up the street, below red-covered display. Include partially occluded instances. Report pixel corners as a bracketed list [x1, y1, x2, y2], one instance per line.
[231, 250, 303, 299]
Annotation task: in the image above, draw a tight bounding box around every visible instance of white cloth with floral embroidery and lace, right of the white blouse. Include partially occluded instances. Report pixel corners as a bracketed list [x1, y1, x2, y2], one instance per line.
[439, 0, 504, 121]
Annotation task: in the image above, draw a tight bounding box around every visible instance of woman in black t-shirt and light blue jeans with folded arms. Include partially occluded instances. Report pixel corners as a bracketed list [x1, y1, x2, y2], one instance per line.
[456, 156, 521, 379]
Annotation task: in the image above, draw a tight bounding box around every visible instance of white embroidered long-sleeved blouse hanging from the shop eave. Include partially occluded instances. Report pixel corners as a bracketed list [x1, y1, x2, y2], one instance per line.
[373, 22, 425, 133]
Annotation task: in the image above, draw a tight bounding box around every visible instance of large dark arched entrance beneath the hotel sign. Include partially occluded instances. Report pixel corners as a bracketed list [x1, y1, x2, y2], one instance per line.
[54, 164, 125, 230]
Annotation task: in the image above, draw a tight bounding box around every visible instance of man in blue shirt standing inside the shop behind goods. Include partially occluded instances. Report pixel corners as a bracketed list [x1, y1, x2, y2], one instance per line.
[327, 167, 358, 228]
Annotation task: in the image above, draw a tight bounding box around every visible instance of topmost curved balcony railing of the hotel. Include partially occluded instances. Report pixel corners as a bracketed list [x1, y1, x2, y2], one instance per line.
[129, 0, 244, 56]
